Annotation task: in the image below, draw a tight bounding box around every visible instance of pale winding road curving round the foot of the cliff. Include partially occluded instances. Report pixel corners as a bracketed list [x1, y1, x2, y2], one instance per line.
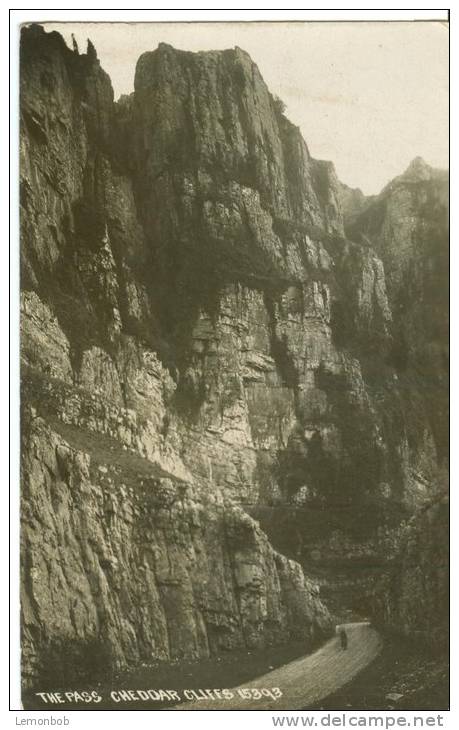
[169, 623, 382, 711]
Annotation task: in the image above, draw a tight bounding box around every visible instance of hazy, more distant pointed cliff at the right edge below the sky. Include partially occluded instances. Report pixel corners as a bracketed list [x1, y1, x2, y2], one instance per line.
[346, 158, 449, 462]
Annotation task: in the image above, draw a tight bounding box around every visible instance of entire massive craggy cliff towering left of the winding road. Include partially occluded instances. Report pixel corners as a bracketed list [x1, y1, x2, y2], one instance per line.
[21, 26, 448, 675]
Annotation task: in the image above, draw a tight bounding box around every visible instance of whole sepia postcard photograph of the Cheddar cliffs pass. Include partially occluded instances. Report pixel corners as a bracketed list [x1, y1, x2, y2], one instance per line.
[17, 11, 450, 712]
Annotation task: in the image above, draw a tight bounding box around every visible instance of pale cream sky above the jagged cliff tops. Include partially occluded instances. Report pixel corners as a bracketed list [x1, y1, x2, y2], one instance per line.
[45, 22, 448, 195]
